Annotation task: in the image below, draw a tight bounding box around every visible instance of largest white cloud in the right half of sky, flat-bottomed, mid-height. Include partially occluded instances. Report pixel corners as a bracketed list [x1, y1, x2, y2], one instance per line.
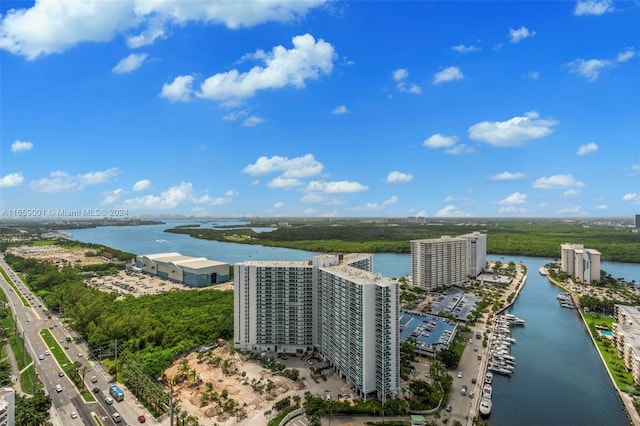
[468, 112, 558, 147]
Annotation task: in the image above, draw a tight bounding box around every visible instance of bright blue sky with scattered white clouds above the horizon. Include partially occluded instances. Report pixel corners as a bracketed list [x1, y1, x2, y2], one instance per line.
[0, 0, 640, 218]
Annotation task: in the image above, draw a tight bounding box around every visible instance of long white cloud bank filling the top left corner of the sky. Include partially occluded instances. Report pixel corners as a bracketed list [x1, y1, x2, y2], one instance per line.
[0, 0, 325, 59]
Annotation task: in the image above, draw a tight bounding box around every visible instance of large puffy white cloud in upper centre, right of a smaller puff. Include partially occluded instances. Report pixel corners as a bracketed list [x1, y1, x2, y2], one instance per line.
[197, 34, 335, 101]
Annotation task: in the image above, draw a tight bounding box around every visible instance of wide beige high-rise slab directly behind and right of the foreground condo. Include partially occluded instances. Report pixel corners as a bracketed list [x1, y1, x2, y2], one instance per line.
[410, 236, 467, 291]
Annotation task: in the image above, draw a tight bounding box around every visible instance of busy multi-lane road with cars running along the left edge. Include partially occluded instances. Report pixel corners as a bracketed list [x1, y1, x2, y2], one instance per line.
[0, 257, 155, 426]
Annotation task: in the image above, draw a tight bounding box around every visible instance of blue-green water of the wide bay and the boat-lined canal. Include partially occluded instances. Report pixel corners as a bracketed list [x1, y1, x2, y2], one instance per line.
[68, 222, 640, 426]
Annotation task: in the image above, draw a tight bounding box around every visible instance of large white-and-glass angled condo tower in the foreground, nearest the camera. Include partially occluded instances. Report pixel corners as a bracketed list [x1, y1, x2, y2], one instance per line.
[234, 254, 400, 401]
